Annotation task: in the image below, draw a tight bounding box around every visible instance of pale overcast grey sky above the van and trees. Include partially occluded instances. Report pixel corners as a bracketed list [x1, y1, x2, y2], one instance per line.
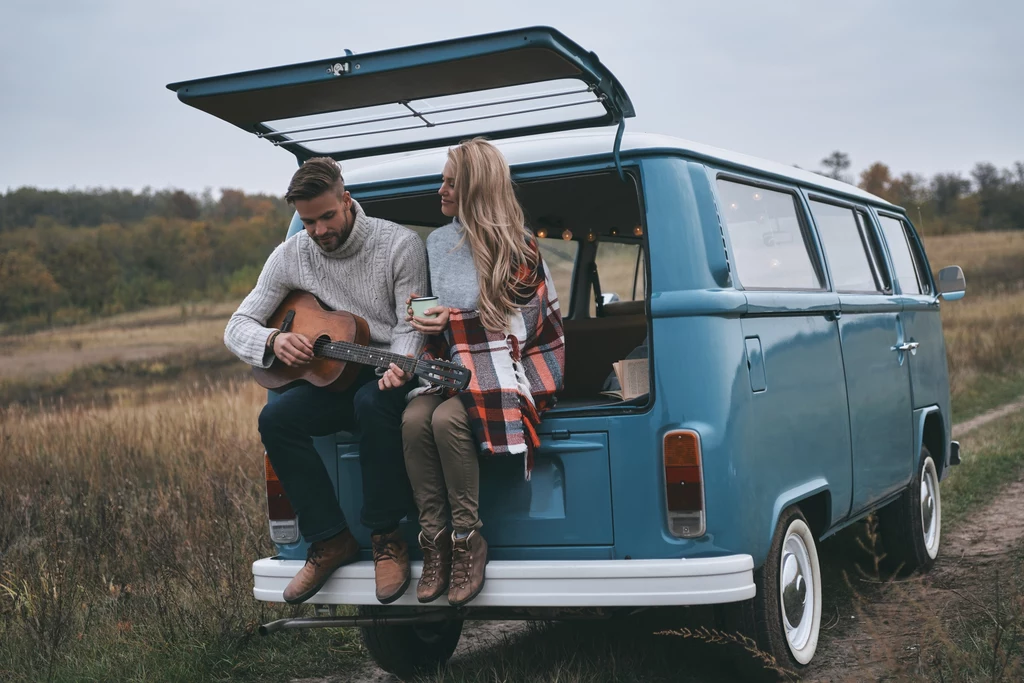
[0, 0, 1024, 193]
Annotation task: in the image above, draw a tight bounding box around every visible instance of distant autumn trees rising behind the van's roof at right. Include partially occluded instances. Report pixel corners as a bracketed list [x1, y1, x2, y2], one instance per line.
[820, 151, 1024, 234]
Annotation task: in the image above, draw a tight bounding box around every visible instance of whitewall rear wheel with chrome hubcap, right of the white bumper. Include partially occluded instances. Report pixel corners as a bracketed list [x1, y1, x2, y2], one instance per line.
[720, 506, 821, 678]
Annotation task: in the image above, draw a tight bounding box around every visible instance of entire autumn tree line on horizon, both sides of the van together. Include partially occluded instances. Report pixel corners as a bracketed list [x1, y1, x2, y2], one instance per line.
[0, 156, 1024, 330]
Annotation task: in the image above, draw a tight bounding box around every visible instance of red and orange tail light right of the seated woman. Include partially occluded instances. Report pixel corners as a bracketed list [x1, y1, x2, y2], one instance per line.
[663, 429, 705, 539]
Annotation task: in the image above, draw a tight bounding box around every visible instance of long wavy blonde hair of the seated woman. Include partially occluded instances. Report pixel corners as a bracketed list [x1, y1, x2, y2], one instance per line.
[449, 137, 543, 332]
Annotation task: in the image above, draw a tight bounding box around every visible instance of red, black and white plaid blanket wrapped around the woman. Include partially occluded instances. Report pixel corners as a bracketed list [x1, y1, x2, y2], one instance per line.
[410, 249, 565, 479]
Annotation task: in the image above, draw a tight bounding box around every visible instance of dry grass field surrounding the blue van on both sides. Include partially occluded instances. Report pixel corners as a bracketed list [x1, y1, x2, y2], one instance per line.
[0, 233, 1024, 681]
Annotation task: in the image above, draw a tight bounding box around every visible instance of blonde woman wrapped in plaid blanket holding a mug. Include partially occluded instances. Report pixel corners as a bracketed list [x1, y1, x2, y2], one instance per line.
[382, 139, 564, 605]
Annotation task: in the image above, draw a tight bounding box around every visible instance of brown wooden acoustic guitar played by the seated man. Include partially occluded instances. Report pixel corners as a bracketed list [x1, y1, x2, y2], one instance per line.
[253, 291, 472, 391]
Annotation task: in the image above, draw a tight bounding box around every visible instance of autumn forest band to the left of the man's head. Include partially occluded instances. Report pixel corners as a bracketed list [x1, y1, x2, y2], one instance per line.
[0, 187, 292, 330]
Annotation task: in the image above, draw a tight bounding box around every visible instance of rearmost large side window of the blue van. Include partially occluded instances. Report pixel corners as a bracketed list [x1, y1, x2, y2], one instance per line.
[718, 178, 821, 290]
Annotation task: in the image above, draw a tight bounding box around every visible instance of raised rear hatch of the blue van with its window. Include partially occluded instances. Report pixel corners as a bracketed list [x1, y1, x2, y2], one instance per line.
[167, 27, 634, 162]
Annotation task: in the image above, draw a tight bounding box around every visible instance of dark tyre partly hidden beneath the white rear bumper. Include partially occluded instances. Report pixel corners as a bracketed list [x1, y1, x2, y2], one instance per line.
[359, 605, 463, 680]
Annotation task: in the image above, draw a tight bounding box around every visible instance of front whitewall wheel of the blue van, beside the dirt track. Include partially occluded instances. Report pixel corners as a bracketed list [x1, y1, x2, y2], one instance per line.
[879, 446, 942, 573]
